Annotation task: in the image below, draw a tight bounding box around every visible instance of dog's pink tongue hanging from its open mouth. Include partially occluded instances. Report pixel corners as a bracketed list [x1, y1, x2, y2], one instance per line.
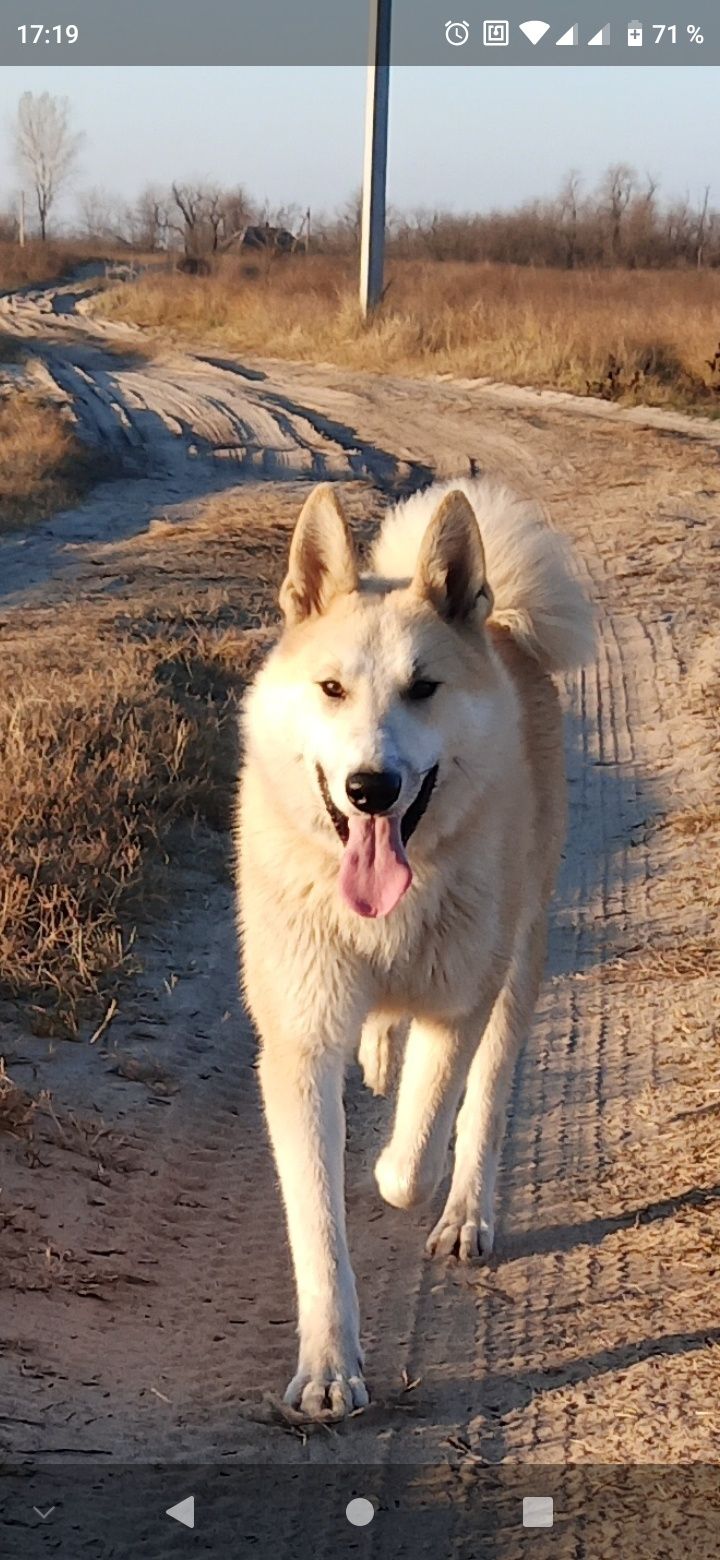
[340, 817, 413, 916]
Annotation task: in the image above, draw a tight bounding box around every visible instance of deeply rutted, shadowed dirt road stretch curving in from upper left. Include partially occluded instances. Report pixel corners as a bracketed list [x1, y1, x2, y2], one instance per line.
[0, 284, 424, 487]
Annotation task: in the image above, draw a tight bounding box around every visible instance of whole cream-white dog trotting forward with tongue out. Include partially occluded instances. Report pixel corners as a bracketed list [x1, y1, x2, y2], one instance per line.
[238, 479, 592, 1415]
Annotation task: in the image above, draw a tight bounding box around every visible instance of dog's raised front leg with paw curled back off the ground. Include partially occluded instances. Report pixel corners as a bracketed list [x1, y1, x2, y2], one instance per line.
[376, 992, 496, 1207]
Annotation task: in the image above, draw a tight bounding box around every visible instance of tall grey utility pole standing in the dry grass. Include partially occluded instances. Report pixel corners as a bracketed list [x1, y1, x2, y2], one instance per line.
[360, 0, 393, 318]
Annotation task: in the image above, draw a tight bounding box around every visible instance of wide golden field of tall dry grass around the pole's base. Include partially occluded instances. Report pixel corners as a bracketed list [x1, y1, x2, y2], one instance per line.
[97, 256, 720, 410]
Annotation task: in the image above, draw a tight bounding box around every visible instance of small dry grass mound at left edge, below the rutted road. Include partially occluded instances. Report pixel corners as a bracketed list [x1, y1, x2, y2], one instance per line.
[0, 390, 94, 532]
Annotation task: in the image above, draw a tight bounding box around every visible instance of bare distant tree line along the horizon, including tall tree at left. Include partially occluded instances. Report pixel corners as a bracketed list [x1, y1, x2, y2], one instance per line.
[0, 92, 720, 270]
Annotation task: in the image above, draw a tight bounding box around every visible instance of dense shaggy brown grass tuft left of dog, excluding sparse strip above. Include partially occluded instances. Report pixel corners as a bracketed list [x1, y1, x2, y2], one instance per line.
[0, 608, 241, 1033]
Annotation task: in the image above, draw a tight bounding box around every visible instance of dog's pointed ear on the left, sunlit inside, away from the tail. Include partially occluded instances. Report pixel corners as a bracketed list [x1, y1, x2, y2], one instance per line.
[281, 482, 358, 624]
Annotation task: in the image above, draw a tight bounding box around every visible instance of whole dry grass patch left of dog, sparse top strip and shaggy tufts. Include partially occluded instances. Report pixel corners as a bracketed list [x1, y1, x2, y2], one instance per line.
[0, 490, 353, 1036]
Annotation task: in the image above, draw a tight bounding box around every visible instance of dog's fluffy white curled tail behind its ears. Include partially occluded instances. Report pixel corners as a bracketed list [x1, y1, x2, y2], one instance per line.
[372, 477, 595, 672]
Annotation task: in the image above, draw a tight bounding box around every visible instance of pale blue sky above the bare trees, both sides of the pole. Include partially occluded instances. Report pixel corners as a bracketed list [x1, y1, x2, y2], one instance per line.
[0, 66, 720, 215]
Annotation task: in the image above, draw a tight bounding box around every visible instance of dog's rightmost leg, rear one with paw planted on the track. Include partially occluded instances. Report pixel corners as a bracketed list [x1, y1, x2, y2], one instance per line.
[427, 914, 545, 1262]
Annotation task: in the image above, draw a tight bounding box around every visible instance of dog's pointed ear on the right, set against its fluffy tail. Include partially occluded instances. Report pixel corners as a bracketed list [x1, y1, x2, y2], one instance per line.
[413, 488, 492, 622]
